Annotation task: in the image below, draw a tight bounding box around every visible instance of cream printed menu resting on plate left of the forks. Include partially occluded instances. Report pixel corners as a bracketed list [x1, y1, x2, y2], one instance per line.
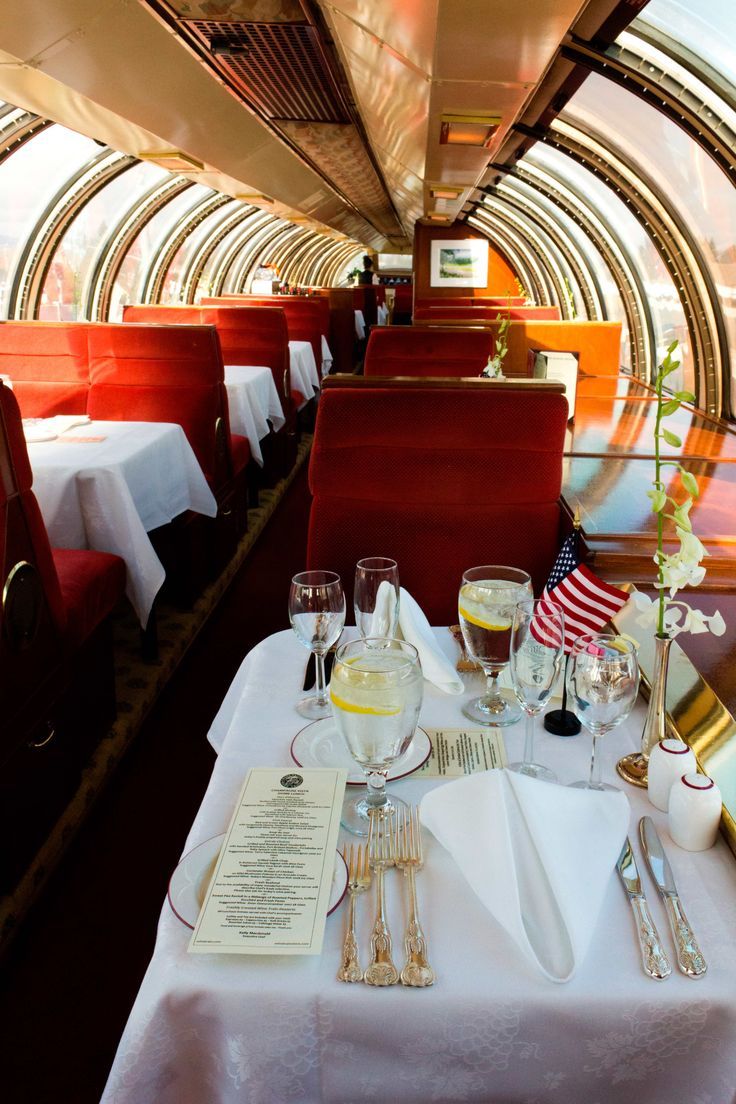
[189, 767, 346, 955]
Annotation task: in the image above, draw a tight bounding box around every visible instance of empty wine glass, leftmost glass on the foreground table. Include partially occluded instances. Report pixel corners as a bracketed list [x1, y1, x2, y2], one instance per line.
[289, 571, 345, 721]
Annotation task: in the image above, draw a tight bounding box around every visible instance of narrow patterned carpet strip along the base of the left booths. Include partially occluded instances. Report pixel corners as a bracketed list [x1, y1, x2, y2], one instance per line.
[0, 436, 311, 949]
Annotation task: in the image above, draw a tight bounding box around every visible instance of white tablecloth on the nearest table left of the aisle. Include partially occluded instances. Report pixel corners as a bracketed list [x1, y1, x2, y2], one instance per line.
[28, 422, 217, 626]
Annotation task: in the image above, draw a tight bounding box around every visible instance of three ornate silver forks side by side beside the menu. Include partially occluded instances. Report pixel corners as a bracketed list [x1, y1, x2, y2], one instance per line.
[337, 807, 435, 988]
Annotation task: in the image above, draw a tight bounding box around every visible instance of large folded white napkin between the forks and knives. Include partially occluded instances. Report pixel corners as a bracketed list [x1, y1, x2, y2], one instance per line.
[420, 771, 629, 981]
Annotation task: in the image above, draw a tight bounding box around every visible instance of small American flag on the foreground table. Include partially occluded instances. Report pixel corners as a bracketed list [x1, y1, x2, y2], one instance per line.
[530, 530, 629, 654]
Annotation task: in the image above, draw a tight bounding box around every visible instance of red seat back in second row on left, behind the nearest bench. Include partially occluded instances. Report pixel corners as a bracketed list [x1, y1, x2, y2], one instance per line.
[122, 304, 291, 412]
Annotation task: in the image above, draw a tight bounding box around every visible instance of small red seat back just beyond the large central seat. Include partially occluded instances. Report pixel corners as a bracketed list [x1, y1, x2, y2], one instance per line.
[363, 327, 495, 376]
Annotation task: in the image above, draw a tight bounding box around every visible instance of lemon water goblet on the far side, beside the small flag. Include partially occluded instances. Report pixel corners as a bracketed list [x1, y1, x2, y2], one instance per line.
[458, 564, 532, 724]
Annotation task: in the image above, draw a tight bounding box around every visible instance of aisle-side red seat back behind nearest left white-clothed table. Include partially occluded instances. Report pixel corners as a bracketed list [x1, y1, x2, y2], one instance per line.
[87, 322, 232, 491]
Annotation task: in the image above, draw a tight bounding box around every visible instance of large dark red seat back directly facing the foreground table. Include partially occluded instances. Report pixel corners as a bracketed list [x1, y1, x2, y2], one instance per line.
[307, 378, 567, 625]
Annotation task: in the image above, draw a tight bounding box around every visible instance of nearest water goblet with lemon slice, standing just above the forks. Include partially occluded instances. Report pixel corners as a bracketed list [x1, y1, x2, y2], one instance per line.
[330, 637, 424, 836]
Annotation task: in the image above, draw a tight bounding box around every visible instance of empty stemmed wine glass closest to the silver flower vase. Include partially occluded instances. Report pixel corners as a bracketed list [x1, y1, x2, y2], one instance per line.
[567, 633, 639, 789]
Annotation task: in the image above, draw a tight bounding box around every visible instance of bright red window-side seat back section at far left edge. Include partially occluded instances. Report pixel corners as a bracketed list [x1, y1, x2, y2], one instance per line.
[0, 321, 89, 417]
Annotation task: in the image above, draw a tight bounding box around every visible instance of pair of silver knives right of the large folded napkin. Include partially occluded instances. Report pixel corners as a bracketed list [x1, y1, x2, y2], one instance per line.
[616, 817, 707, 981]
